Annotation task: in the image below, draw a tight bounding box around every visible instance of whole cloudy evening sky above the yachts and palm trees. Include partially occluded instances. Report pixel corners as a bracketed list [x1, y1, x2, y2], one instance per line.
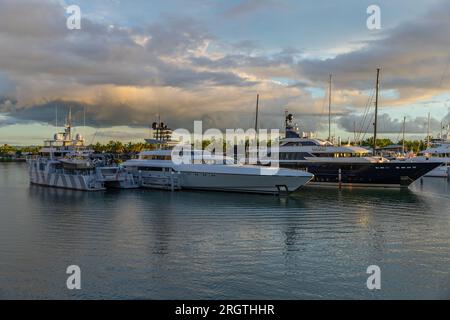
[0, 0, 450, 145]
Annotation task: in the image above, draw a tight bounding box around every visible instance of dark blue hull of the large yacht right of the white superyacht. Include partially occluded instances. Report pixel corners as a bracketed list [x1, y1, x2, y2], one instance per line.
[280, 161, 440, 187]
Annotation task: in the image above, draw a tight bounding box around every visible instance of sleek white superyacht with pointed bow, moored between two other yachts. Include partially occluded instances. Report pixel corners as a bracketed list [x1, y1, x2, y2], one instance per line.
[123, 124, 314, 194]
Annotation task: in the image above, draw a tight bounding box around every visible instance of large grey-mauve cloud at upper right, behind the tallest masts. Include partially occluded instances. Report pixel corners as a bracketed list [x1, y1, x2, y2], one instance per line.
[298, 1, 450, 109]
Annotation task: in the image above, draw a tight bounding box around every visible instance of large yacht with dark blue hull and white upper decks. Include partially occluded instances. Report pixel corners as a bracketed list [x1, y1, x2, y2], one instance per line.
[279, 114, 440, 187]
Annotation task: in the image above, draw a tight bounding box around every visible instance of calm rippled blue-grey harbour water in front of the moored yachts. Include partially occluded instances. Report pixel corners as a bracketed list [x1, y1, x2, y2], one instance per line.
[0, 164, 450, 299]
